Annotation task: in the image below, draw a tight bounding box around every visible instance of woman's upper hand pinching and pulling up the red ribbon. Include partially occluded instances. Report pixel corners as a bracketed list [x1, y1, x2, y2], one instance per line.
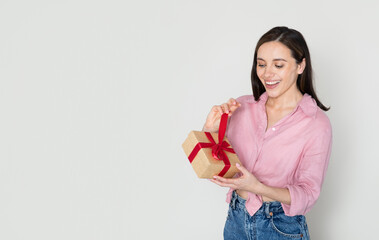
[203, 98, 241, 132]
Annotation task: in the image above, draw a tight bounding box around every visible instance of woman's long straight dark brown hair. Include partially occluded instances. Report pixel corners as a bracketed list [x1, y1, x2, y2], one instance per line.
[251, 27, 329, 111]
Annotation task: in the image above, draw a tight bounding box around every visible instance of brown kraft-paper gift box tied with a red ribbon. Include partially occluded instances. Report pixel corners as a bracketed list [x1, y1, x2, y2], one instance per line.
[182, 114, 241, 178]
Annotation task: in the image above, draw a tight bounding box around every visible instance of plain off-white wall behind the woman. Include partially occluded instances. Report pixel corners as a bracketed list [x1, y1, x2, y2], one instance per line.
[0, 0, 379, 240]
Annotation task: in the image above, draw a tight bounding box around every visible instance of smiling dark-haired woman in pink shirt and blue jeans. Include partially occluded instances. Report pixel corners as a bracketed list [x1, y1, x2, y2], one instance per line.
[203, 27, 332, 240]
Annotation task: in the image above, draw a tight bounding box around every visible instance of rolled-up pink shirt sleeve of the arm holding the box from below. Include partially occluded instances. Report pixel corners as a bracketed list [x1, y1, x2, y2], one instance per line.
[282, 125, 332, 216]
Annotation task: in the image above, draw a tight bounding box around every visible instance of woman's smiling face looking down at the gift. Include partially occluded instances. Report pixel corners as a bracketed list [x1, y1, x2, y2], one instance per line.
[257, 41, 305, 98]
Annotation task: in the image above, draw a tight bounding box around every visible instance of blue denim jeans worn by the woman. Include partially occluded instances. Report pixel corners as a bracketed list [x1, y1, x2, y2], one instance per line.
[224, 191, 309, 240]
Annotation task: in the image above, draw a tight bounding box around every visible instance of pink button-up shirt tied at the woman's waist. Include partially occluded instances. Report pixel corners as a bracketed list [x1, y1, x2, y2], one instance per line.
[226, 92, 332, 216]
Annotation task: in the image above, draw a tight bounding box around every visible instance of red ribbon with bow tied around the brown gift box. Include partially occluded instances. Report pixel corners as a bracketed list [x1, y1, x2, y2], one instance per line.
[188, 113, 235, 177]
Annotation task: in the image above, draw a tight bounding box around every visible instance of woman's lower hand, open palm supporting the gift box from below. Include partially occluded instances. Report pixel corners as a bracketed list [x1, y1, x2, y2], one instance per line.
[211, 163, 263, 194]
